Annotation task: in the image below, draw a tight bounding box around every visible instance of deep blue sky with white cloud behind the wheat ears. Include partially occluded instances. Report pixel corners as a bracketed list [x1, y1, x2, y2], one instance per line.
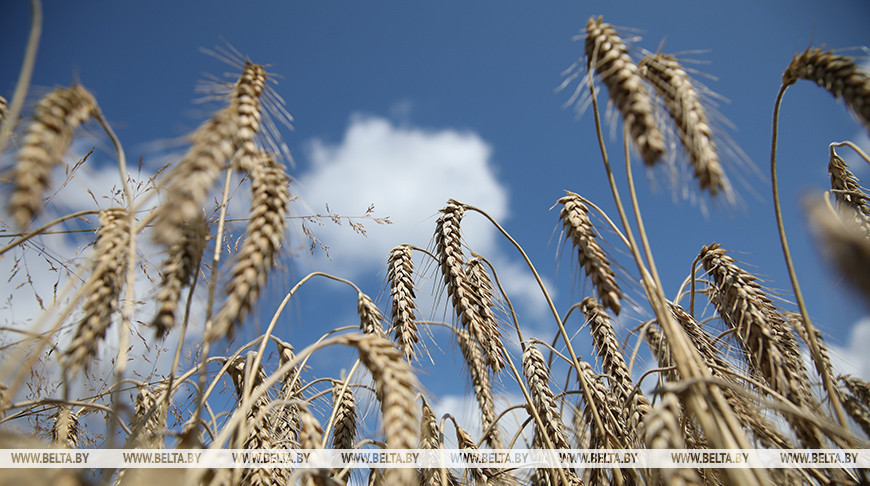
[0, 1, 870, 432]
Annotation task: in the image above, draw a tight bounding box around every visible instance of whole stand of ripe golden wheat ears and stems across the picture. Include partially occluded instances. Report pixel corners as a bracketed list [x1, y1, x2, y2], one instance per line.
[0, 3, 870, 485]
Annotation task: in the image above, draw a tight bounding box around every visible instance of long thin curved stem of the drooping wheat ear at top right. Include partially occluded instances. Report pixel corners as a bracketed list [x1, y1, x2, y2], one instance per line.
[770, 85, 849, 430]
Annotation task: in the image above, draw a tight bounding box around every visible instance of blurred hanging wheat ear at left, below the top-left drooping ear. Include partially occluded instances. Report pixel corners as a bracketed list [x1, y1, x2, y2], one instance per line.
[66, 208, 131, 374]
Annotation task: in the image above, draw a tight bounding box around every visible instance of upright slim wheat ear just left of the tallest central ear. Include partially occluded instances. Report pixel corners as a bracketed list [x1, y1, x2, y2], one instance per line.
[387, 245, 418, 361]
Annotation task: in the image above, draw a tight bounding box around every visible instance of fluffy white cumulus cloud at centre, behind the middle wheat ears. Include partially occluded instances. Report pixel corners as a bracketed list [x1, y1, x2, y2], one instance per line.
[296, 115, 543, 318]
